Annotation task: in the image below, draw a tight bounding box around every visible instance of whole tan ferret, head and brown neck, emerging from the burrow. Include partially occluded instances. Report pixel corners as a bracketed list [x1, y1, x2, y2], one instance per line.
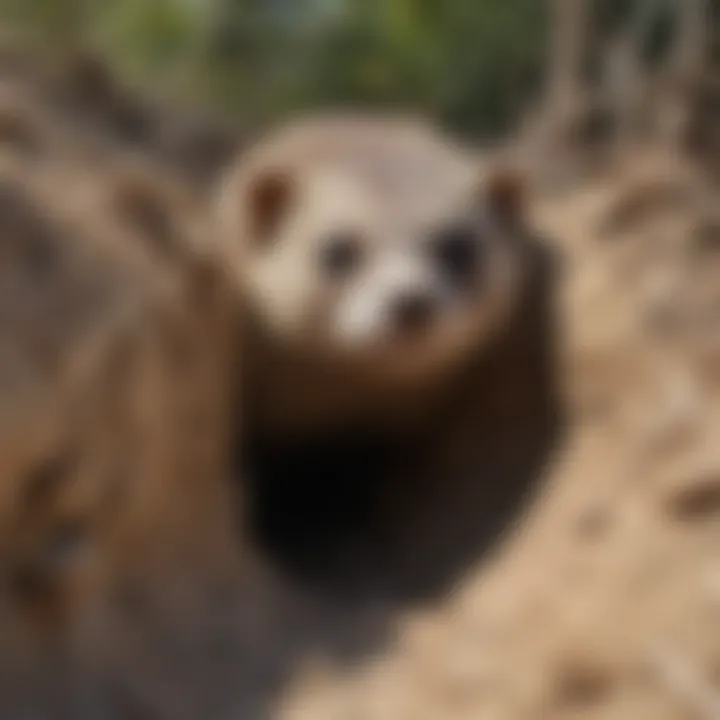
[220, 115, 523, 437]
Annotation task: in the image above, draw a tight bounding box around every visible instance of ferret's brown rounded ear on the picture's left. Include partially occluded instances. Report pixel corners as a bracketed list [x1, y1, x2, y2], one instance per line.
[246, 168, 295, 246]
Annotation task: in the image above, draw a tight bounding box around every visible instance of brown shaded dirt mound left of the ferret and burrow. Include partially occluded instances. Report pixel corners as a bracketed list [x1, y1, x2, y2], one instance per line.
[0, 142, 251, 714]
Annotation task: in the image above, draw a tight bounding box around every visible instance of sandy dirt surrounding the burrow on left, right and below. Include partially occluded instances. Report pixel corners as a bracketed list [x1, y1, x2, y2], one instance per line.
[0, 47, 720, 720]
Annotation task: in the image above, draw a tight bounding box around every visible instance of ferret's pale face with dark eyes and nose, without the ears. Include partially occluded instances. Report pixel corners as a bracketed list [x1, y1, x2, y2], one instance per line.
[245, 158, 513, 382]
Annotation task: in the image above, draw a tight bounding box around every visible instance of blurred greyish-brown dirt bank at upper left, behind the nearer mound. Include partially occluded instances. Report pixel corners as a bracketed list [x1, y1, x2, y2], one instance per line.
[0, 44, 238, 187]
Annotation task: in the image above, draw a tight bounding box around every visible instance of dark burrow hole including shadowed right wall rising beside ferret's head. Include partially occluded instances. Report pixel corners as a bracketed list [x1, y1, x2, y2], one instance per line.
[235, 235, 563, 602]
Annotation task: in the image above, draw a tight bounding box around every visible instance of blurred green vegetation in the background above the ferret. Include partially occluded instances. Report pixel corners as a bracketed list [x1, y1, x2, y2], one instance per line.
[0, 0, 708, 136]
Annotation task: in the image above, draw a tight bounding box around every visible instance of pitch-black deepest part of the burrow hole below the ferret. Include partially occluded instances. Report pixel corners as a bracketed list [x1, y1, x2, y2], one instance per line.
[242, 434, 406, 590]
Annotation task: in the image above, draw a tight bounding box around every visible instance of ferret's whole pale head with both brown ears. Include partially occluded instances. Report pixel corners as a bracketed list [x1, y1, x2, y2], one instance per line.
[218, 122, 522, 378]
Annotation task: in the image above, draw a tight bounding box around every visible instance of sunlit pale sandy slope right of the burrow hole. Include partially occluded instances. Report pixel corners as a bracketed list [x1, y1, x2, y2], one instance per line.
[278, 152, 720, 720]
